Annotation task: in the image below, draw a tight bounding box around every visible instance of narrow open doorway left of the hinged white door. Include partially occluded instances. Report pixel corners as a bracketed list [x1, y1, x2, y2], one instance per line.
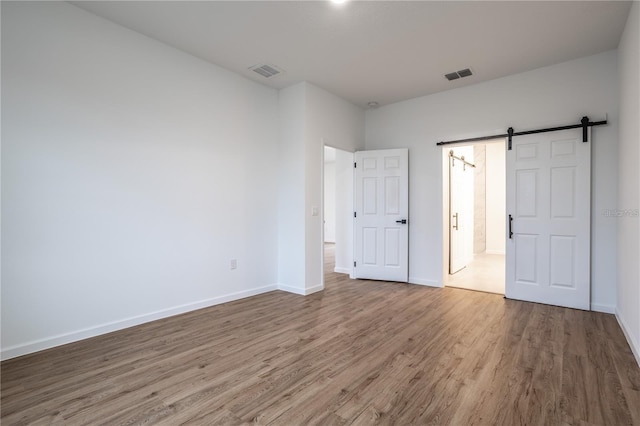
[323, 145, 354, 284]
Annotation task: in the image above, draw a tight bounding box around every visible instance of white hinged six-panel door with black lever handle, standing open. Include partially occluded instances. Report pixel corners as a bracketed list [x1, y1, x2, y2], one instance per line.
[354, 149, 409, 282]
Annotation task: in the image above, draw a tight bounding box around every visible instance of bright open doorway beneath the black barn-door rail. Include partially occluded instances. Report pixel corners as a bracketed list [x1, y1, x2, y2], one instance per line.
[443, 139, 506, 294]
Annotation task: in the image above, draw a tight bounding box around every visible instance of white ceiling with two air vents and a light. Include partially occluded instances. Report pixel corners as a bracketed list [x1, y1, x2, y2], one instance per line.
[72, 1, 631, 107]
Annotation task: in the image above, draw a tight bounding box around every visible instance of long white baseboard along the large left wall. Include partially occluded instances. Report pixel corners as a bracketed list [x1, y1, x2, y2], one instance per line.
[0, 284, 278, 361]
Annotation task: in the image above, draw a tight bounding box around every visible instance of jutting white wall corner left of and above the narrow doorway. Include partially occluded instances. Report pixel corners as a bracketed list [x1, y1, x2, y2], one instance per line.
[279, 82, 364, 294]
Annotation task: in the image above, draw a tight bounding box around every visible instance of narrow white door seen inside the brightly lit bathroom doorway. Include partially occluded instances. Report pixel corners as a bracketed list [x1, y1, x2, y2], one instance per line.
[449, 146, 474, 274]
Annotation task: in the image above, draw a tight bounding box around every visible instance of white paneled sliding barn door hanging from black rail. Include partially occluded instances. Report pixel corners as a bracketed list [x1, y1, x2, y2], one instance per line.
[505, 129, 591, 310]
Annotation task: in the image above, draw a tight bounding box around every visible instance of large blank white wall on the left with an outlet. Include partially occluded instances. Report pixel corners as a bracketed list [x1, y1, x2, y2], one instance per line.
[2, 2, 280, 358]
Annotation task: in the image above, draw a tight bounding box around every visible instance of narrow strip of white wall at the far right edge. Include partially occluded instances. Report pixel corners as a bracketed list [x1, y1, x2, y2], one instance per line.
[609, 1, 640, 364]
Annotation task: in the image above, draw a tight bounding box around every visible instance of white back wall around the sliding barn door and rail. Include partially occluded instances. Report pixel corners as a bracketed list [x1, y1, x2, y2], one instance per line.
[366, 51, 618, 312]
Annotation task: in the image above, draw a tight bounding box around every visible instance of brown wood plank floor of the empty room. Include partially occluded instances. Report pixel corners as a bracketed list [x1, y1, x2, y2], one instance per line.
[0, 245, 640, 426]
